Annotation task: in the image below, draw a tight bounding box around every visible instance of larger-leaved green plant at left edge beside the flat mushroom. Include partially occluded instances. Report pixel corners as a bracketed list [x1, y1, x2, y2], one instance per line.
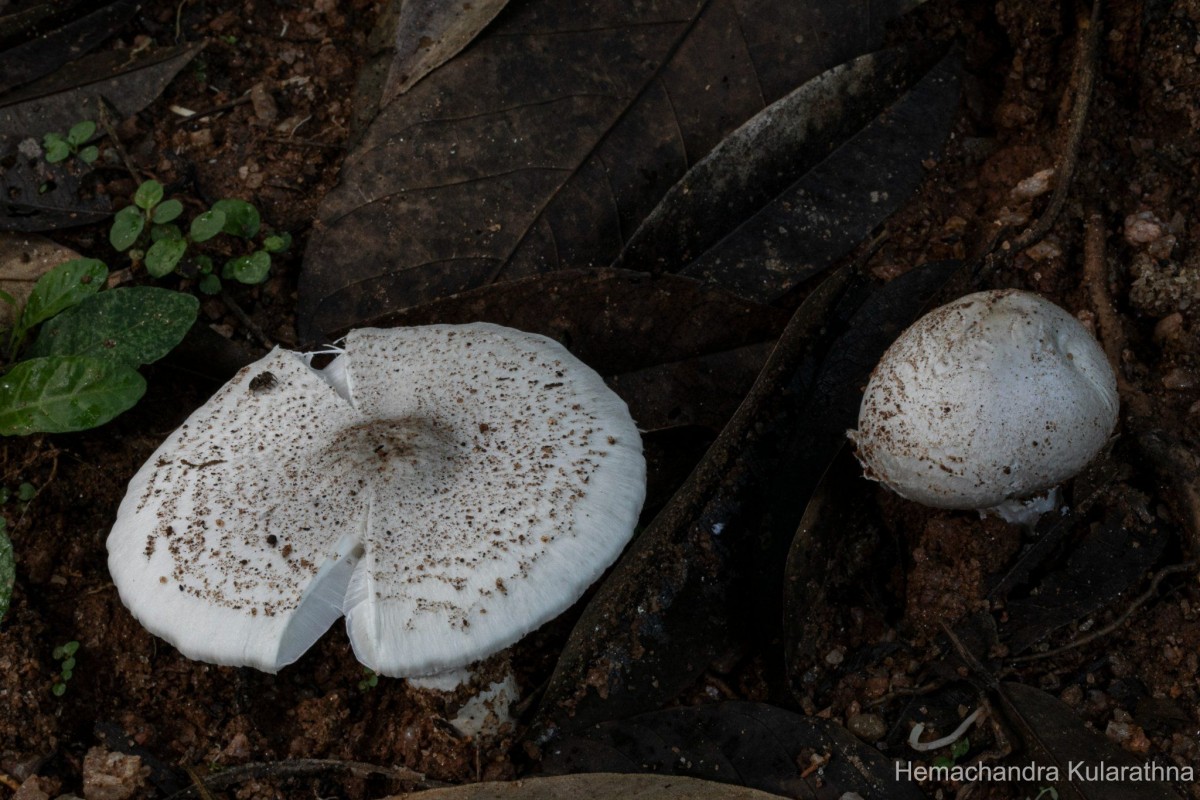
[0, 258, 199, 434]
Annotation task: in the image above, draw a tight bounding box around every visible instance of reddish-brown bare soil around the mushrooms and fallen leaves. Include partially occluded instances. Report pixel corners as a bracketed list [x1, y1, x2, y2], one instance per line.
[0, 0, 1200, 799]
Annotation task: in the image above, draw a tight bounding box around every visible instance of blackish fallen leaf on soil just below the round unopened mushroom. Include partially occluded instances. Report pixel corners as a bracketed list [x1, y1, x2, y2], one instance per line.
[1000, 510, 1169, 655]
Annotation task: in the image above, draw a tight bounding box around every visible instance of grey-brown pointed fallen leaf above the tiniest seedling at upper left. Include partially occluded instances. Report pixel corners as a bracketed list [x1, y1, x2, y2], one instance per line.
[0, 43, 204, 139]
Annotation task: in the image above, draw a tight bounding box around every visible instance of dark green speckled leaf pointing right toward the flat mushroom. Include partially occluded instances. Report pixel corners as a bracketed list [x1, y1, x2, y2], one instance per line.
[30, 287, 200, 367]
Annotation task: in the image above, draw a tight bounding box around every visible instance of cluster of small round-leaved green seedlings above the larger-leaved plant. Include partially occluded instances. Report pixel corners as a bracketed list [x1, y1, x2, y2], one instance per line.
[108, 180, 292, 294]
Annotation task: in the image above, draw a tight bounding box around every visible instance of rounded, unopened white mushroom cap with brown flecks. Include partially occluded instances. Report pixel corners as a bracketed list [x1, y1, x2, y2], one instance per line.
[850, 289, 1118, 509]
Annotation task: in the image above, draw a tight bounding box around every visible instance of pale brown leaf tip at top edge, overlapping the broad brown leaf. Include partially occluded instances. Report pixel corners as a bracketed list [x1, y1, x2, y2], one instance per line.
[382, 0, 509, 104]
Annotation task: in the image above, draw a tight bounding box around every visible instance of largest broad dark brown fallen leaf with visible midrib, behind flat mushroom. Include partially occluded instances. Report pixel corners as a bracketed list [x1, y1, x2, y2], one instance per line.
[296, 0, 926, 338]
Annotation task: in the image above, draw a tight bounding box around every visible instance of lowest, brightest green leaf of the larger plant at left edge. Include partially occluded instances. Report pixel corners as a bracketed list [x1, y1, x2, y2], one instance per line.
[0, 355, 146, 437]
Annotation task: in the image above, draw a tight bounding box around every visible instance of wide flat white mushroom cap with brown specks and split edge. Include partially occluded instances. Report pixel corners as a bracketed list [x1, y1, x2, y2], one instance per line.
[108, 324, 646, 676]
